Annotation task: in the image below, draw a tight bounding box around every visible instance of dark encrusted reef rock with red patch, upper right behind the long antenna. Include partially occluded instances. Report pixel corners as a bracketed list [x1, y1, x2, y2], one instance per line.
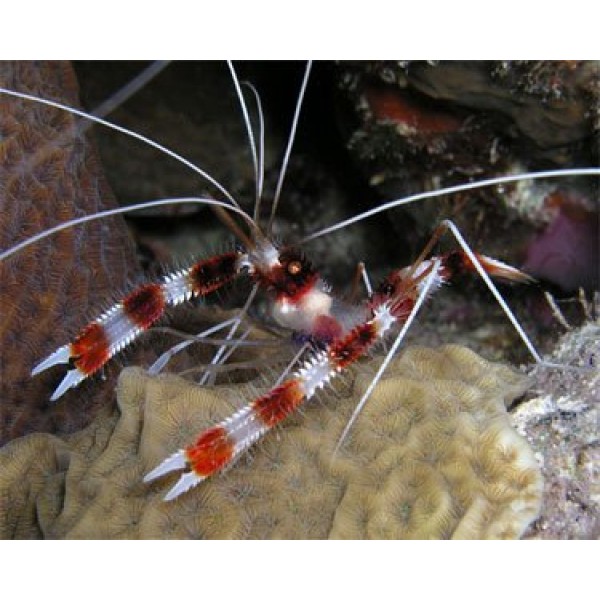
[337, 61, 600, 291]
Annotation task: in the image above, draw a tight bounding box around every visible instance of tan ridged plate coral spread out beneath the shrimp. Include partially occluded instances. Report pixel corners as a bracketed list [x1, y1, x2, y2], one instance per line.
[0, 346, 542, 538]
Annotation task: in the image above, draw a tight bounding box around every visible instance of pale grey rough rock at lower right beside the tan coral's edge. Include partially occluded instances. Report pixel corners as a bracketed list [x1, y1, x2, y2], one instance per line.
[512, 321, 600, 539]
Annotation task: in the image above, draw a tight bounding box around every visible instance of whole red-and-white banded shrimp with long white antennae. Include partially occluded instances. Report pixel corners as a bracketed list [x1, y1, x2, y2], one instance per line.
[2, 65, 600, 500]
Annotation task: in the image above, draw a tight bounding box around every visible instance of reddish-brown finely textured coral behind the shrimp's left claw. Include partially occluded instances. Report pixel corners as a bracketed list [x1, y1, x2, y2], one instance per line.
[0, 62, 139, 445]
